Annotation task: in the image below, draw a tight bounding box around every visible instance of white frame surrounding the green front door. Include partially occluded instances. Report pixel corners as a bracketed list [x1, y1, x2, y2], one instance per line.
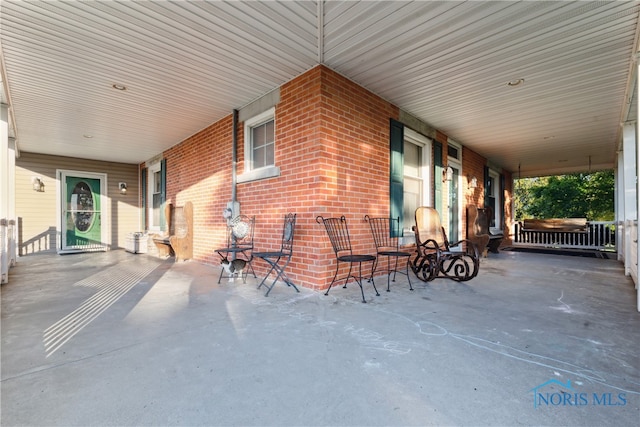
[56, 169, 111, 254]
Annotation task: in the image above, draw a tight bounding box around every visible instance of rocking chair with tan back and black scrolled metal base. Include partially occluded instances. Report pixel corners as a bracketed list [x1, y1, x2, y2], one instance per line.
[411, 206, 480, 282]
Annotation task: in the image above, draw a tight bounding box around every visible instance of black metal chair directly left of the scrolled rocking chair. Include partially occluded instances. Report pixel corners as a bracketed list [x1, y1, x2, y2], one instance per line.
[364, 215, 413, 292]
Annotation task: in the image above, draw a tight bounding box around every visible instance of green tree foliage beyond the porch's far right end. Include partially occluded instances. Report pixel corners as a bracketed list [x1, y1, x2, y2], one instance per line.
[514, 170, 614, 221]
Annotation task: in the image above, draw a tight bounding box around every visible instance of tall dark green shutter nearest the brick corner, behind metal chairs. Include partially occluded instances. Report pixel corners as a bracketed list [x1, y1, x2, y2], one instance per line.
[389, 119, 404, 237]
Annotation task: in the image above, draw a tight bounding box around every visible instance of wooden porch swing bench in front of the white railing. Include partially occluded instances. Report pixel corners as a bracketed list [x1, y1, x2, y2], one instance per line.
[517, 218, 589, 246]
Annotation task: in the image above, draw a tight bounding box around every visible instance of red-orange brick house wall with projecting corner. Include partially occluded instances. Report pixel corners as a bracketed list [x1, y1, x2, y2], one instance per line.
[154, 66, 510, 289]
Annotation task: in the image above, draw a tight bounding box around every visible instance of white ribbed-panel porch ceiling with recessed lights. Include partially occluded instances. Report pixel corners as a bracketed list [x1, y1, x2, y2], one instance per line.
[0, 0, 640, 176]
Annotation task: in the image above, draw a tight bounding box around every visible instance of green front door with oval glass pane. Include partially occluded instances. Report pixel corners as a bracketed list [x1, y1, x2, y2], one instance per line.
[62, 175, 104, 251]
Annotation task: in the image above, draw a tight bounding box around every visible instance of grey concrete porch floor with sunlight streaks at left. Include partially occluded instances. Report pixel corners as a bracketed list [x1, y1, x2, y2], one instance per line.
[0, 250, 640, 426]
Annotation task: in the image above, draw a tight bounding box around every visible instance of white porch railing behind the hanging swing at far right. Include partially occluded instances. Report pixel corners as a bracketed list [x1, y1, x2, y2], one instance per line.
[513, 221, 617, 251]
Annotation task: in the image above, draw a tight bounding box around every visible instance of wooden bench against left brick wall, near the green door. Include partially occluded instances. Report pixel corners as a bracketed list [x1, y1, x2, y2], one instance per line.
[153, 202, 193, 261]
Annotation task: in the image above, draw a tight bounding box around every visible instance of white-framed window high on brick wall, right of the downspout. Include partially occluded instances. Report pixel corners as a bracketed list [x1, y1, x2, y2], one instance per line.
[238, 108, 280, 182]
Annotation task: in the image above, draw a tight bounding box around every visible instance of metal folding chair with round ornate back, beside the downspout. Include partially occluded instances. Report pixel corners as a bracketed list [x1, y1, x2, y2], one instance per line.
[215, 215, 257, 283]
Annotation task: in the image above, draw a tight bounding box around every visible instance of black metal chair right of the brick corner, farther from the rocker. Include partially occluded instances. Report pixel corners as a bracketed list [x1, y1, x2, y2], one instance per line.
[316, 215, 380, 302]
